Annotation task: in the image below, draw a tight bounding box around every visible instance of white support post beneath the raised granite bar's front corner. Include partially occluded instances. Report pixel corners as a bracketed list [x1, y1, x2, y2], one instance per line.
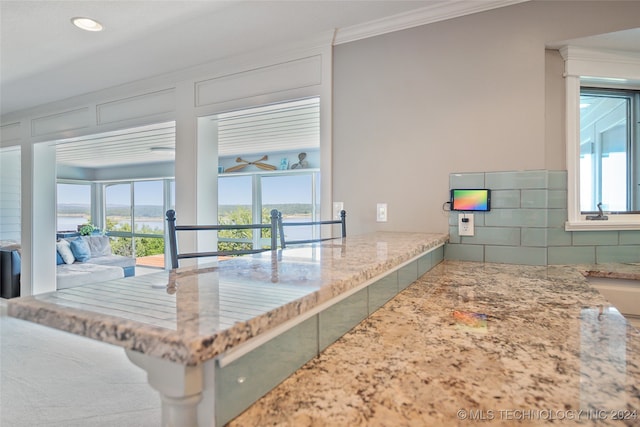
[125, 349, 213, 427]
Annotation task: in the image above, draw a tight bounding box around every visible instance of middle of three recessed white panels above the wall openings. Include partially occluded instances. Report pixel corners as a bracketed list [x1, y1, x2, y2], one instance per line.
[96, 88, 176, 124]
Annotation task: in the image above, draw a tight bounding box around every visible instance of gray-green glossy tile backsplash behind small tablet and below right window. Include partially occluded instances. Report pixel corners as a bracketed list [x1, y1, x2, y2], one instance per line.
[444, 170, 640, 265]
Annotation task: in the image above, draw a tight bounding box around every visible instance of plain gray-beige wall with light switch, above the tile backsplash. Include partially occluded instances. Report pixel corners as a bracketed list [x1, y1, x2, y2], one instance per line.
[333, 1, 640, 233]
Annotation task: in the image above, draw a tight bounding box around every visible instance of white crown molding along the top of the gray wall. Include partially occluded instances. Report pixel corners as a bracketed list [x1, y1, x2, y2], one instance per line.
[333, 0, 529, 45]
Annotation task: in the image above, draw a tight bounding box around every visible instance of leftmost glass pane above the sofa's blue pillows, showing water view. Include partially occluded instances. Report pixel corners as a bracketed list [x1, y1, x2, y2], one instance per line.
[56, 184, 91, 231]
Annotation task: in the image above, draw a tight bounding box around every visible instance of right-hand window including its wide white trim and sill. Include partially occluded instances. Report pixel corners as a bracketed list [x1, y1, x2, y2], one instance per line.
[560, 46, 640, 231]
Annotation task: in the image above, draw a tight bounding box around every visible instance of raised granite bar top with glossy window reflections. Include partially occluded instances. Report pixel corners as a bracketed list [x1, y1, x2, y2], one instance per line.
[8, 232, 448, 365]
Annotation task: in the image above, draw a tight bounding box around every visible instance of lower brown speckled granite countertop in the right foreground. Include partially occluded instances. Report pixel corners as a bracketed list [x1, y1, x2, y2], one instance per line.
[229, 261, 640, 427]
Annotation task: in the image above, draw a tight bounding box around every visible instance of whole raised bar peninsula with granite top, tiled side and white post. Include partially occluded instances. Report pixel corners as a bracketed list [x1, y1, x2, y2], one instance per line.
[8, 232, 448, 426]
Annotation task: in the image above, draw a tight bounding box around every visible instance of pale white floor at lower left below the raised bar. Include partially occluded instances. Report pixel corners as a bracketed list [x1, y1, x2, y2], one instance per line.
[0, 299, 161, 427]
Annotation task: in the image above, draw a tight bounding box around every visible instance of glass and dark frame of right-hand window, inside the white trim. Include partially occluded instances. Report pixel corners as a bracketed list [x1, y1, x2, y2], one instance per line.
[580, 88, 640, 213]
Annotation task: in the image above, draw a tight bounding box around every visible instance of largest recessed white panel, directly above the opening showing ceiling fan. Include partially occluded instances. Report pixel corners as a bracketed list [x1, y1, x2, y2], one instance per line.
[195, 55, 322, 107]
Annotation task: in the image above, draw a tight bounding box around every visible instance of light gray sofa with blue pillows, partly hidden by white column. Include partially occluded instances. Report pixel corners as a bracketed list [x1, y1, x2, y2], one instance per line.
[0, 235, 136, 298]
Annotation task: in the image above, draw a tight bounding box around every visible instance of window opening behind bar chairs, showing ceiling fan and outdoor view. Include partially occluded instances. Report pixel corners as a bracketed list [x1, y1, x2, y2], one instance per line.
[211, 97, 320, 250]
